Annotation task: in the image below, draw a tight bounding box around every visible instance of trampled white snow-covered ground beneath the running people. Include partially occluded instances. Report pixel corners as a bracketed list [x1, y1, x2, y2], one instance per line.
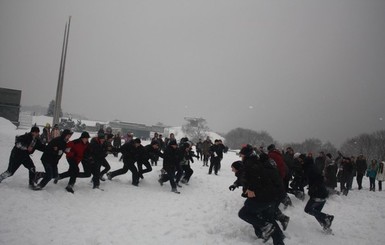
[0, 118, 385, 245]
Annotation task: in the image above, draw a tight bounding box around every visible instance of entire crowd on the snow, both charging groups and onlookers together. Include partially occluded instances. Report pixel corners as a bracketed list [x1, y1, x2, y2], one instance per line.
[0, 124, 385, 245]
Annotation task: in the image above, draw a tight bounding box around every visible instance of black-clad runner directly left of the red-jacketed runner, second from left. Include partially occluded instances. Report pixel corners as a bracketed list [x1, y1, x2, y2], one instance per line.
[34, 129, 73, 191]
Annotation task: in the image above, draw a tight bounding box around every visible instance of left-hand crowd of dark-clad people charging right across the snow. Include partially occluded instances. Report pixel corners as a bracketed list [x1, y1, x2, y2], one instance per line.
[0, 124, 227, 194]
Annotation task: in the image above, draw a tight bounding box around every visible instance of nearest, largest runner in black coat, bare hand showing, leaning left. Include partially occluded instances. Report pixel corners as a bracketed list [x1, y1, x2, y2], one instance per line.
[238, 145, 284, 245]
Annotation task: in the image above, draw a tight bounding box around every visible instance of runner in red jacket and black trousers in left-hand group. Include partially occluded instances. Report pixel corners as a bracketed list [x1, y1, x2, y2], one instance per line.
[55, 132, 90, 193]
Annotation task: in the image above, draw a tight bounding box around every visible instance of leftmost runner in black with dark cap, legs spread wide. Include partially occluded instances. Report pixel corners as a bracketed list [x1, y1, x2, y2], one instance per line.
[0, 126, 45, 189]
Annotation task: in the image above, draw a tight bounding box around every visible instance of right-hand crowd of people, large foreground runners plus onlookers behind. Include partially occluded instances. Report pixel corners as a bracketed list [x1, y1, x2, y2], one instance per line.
[229, 144, 385, 245]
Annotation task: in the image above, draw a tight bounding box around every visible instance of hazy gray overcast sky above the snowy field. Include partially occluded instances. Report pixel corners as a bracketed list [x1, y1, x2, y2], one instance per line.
[0, 0, 385, 146]
